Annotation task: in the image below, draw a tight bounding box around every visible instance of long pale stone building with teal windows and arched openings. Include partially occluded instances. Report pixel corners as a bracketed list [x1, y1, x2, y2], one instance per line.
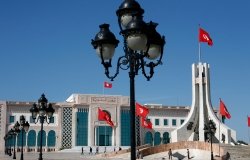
[0, 94, 189, 152]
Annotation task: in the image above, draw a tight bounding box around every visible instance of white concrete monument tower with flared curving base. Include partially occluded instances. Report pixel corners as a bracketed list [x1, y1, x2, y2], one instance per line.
[171, 62, 236, 143]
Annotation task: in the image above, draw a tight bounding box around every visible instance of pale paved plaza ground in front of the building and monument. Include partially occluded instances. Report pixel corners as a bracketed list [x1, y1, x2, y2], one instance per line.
[0, 145, 250, 160]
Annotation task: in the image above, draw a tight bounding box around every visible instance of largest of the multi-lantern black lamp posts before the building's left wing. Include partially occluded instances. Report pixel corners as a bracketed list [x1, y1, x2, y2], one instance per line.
[30, 94, 55, 160]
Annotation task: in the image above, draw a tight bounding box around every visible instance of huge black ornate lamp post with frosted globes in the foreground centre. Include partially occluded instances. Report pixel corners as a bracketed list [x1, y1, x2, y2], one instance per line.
[91, 0, 165, 160]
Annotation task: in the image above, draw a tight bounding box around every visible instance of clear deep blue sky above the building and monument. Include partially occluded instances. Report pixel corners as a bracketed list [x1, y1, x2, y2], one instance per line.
[0, 0, 250, 142]
